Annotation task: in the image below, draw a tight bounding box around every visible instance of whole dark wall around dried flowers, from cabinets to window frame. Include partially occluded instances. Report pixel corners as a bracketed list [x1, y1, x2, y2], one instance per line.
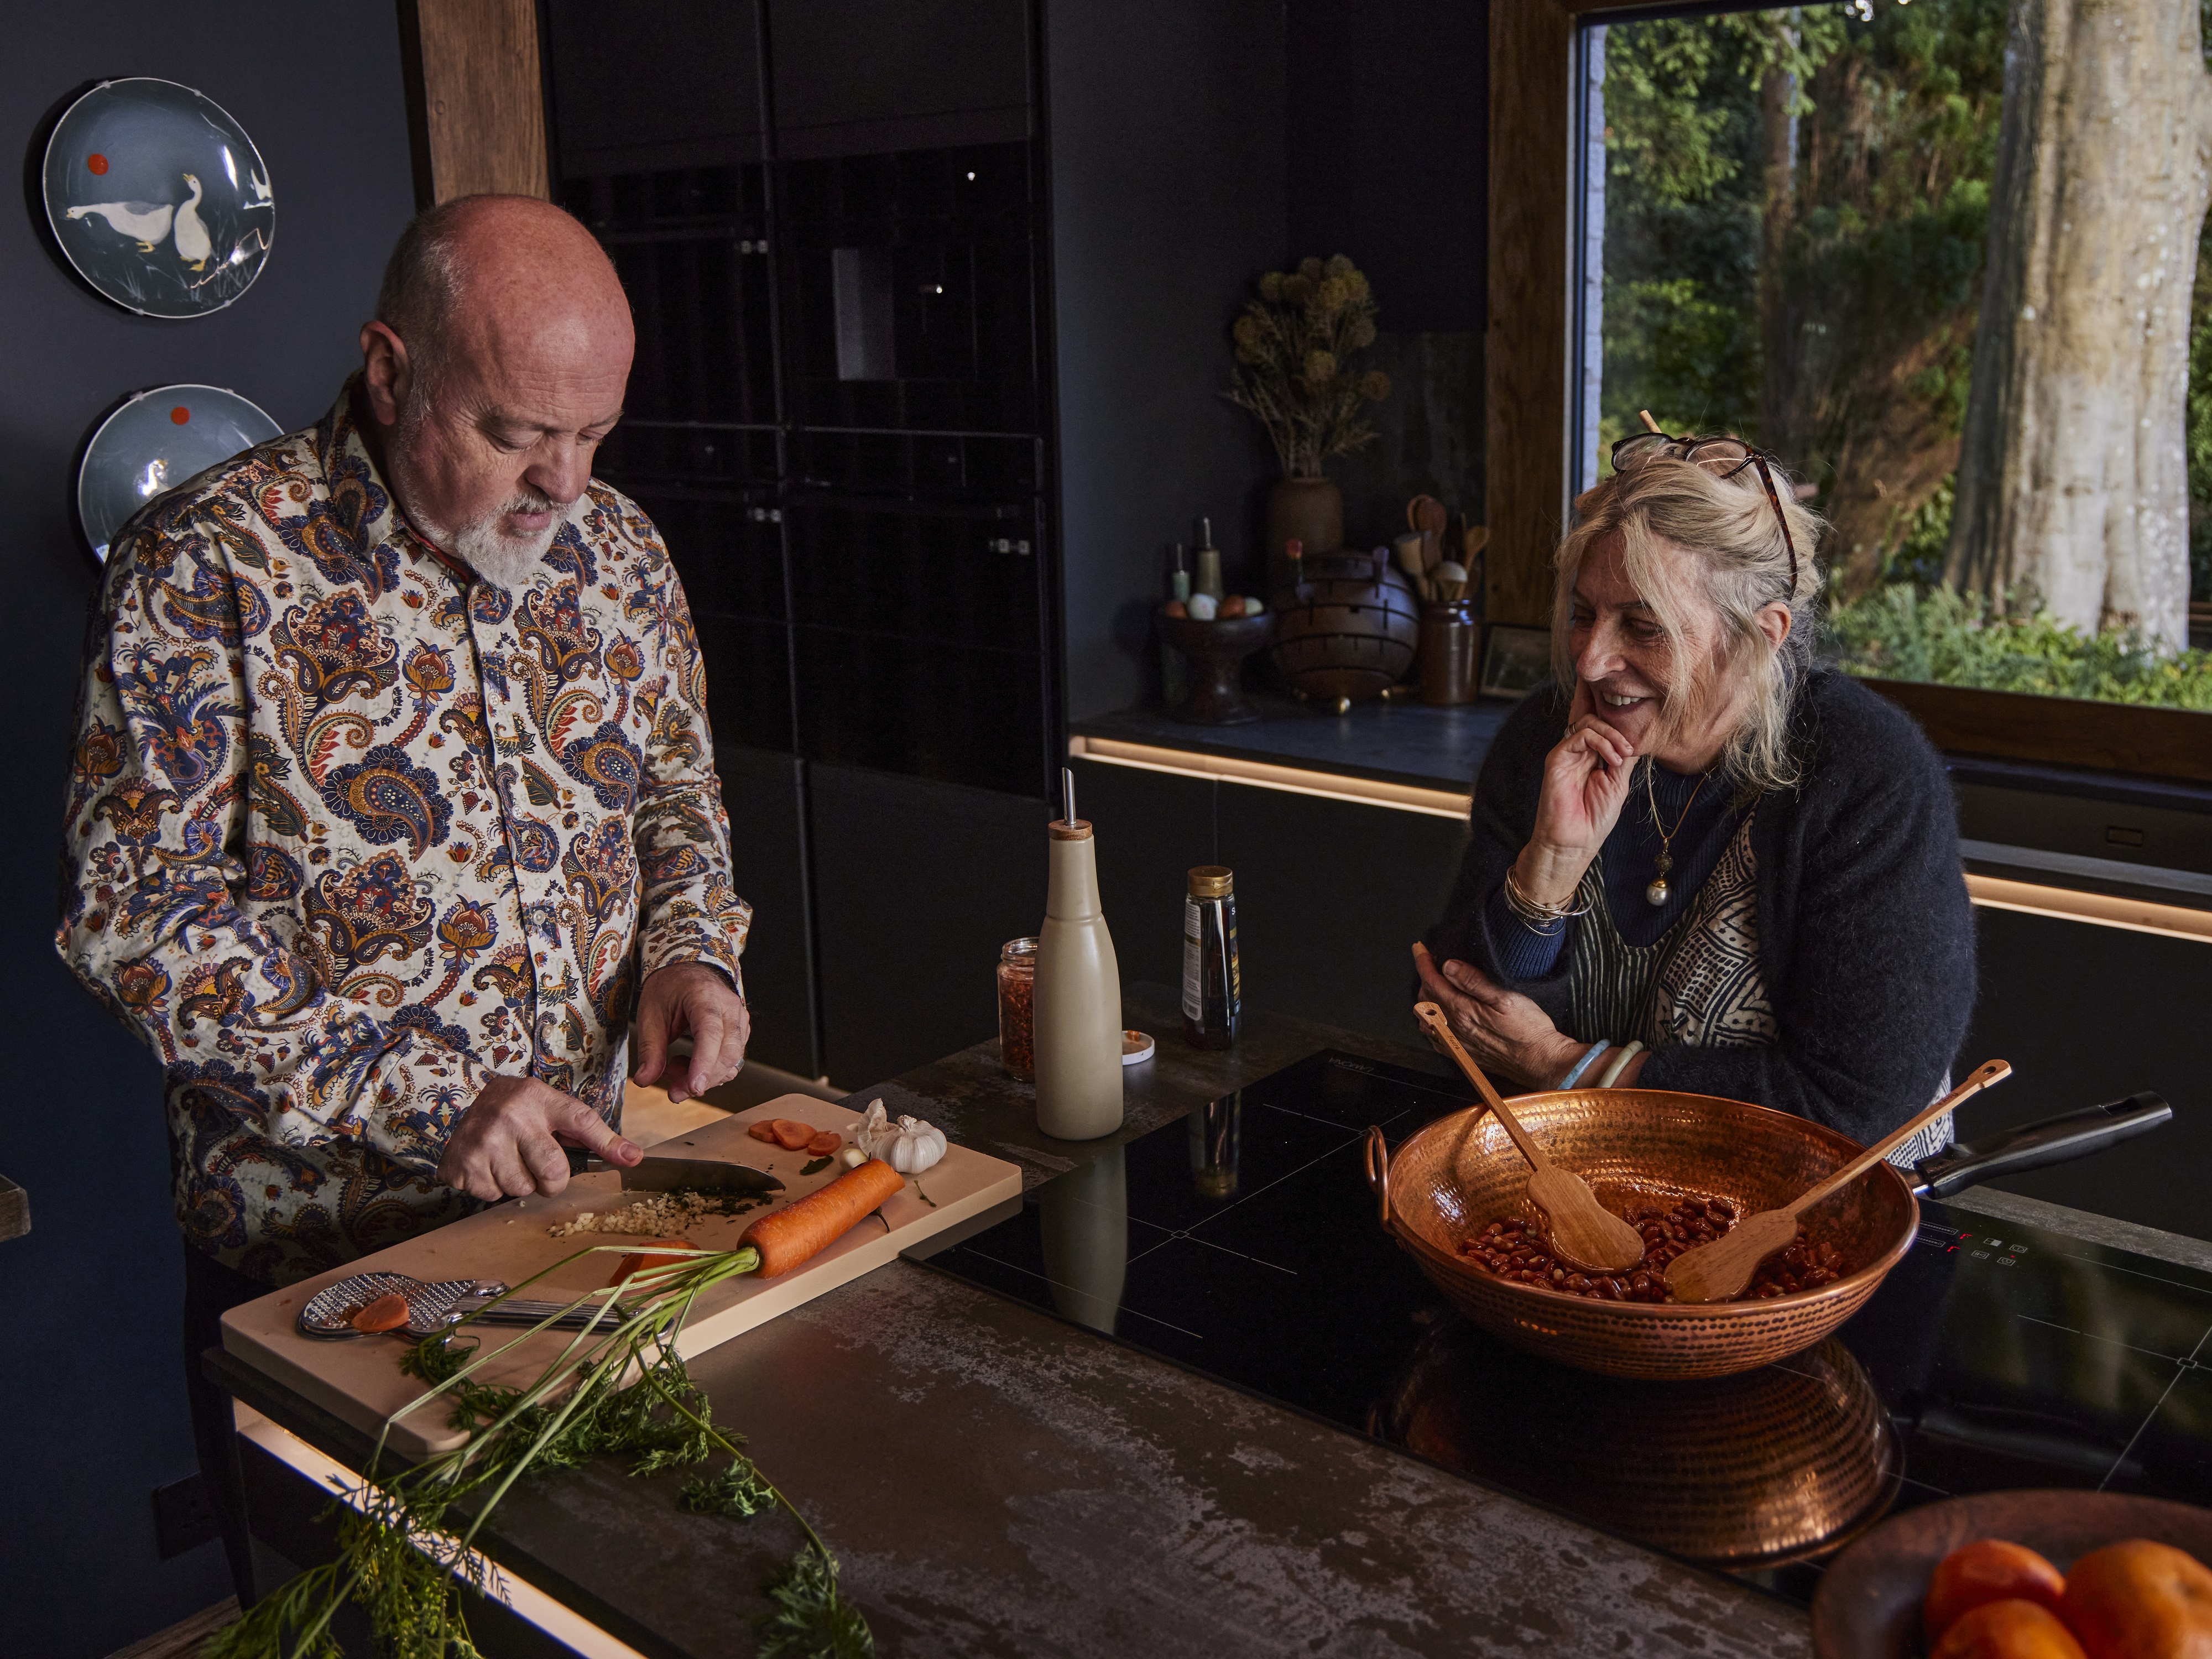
[1044, 0, 1489, 719]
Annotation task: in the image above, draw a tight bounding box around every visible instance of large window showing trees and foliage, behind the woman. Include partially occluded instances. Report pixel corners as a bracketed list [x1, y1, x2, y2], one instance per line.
[1571, 0, 2212, 710]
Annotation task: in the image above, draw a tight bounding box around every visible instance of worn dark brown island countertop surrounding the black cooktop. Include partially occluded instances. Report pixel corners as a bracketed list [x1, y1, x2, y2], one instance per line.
[210, 984, 2212, 1659]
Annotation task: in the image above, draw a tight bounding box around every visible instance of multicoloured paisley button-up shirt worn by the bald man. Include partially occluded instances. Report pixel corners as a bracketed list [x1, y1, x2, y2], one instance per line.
[55, 383, 752, 1283]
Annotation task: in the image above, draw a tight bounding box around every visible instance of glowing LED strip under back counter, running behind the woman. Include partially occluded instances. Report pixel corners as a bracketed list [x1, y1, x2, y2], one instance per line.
[1068, 737, 2212, 945]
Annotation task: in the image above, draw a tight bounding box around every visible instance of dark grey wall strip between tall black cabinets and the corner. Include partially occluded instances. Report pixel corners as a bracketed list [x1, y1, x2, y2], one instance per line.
[1044, 0, 1287, 719]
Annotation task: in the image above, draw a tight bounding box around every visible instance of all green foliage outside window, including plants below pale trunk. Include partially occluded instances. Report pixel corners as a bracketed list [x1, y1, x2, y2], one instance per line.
[1599, 0, 2212, 710]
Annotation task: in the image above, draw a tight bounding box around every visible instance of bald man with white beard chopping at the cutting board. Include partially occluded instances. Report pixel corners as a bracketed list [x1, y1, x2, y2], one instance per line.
[58, 197, 750, 1601]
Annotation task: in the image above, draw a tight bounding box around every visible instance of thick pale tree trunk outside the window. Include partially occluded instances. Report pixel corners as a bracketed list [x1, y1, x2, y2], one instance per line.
[1944, 0, 2212, 646]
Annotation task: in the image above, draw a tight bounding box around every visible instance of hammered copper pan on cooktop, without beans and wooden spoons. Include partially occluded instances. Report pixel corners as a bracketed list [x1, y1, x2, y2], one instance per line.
[1367, 1088, 1920, 1380]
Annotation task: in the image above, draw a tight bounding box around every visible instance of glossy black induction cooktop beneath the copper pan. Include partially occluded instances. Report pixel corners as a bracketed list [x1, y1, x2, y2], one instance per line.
[907, 1051, 2212, 1599]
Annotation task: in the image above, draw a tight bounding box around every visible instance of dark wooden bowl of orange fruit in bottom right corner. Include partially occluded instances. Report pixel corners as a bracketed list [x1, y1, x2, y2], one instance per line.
[1812, 1491, 2212, 1659]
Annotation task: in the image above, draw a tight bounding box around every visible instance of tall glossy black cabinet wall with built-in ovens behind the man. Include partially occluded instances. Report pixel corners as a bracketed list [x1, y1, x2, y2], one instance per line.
[542, 0, 1066, 1086]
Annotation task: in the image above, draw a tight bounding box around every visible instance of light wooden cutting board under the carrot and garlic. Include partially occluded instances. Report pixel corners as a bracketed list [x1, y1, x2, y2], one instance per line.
[223, 1095, 1022, 1458]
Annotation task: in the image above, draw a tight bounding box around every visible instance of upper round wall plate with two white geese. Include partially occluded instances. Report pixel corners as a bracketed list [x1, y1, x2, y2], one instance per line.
[44, 75, 276, 319]
